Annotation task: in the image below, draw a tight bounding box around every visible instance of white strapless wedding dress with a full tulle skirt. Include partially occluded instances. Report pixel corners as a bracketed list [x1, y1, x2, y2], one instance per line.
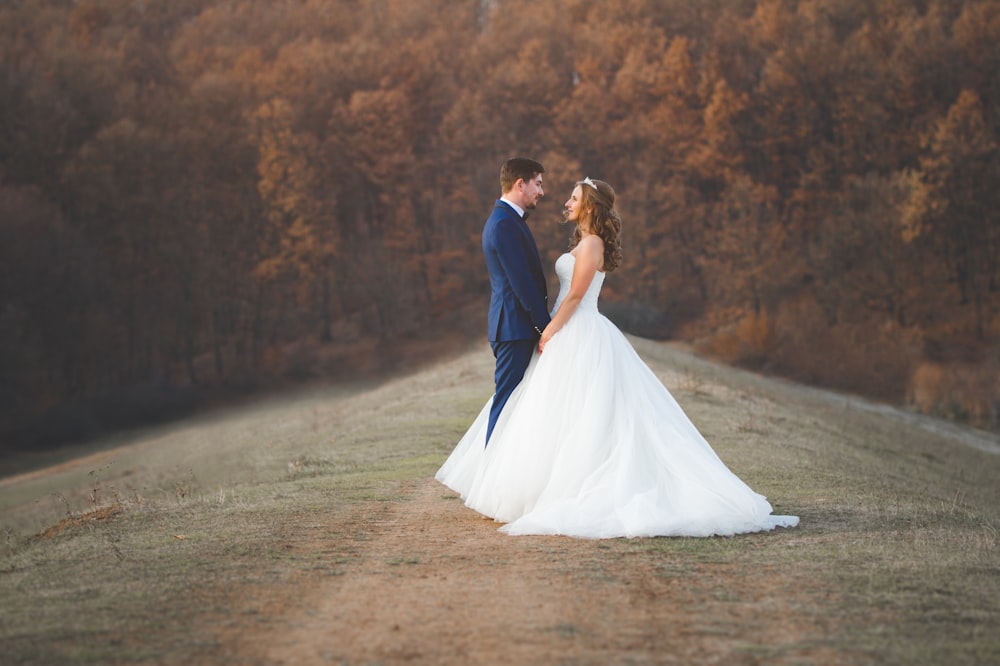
[436, 254, 799, 538]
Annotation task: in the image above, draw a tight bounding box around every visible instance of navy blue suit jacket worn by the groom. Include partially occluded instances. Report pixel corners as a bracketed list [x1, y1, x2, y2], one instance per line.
[483, 199, 549, 342]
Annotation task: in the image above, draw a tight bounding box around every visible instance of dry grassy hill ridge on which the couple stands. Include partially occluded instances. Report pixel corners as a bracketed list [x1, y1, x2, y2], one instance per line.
[0, 339, 1000, 665]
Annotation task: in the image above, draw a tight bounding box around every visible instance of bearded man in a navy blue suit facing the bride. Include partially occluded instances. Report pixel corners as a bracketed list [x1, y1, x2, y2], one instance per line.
[483, 157, 549, 444]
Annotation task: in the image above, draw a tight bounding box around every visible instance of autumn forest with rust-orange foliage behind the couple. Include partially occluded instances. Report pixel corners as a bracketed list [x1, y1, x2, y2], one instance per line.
[0, 0, 1000, 446]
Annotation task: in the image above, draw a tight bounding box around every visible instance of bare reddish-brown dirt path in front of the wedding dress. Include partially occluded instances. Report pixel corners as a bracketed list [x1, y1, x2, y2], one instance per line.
[218, 479, 842, 664]
